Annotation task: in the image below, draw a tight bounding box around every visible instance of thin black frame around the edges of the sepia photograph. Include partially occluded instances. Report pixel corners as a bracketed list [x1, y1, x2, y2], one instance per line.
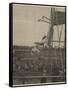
[9, 2, 67, 87]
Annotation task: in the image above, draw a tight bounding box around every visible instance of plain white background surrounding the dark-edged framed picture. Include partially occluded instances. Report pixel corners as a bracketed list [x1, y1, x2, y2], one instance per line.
[0, 0, 68, 90]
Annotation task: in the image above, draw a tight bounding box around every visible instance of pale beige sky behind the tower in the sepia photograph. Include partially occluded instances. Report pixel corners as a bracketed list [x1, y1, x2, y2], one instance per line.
[13, 4, 64, 46]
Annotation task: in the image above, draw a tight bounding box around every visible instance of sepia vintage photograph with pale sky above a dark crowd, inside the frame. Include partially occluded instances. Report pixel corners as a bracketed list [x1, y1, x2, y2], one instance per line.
[11, 3, 66, 86]
